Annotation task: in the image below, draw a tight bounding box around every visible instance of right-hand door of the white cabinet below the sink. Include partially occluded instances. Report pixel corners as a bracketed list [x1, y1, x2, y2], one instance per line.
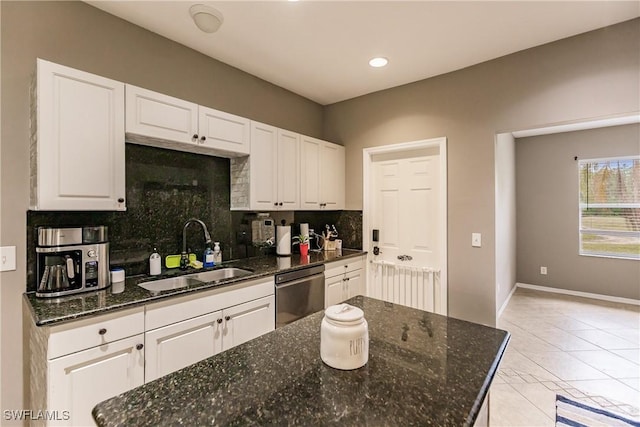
[222, 295, 276, 350]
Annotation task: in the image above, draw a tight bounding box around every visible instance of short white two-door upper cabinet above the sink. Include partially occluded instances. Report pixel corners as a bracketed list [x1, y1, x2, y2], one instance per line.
[126, 85, 250, 157]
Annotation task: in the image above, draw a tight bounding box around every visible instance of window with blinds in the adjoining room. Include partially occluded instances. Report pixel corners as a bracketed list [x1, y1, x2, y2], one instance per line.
[579, 156, 640, 259]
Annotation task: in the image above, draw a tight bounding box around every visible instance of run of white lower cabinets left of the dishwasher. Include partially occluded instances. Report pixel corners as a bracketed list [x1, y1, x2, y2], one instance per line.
[30, 276, 275, 426]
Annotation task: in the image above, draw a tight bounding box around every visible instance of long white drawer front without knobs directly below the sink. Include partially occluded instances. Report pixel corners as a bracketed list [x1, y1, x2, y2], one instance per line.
[145, 276, 275, 331]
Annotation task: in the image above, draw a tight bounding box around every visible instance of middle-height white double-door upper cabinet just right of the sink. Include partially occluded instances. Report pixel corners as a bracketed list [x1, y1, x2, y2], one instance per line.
[231, 121, 300, 211]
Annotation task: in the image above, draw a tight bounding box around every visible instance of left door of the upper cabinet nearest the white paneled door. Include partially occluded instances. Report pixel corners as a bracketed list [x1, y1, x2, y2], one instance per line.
[300, 135, 322, 210]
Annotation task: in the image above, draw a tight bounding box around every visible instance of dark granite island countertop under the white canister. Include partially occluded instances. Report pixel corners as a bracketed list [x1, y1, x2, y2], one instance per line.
[93, 296, 509, 426]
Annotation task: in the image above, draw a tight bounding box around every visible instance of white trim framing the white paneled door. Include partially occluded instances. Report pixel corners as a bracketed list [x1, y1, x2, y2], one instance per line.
[362, 137, 449, 315]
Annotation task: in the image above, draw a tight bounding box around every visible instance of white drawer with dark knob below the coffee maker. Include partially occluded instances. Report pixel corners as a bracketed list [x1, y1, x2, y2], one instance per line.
[47, 307, 144, 359]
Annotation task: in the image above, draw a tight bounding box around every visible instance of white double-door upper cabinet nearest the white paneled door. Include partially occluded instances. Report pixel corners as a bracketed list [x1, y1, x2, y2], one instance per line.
[299, 135, 345, 210]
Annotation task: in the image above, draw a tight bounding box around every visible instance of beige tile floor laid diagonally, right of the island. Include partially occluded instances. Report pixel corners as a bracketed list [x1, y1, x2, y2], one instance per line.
[489, 288, 640, 427]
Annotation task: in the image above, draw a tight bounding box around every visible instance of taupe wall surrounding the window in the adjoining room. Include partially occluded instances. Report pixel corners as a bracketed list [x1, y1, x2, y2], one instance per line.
[516, 125, 640, 299]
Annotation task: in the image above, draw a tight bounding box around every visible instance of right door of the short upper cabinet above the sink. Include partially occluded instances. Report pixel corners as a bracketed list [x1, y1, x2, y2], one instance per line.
[198, 106, 251, 157]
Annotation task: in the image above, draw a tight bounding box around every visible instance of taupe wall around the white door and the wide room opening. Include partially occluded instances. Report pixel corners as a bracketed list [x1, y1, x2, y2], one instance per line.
[324, 19, 640, 325]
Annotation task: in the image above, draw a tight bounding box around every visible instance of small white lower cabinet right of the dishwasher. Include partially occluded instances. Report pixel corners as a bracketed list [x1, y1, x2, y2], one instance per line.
[324, 258, 365, 308]
